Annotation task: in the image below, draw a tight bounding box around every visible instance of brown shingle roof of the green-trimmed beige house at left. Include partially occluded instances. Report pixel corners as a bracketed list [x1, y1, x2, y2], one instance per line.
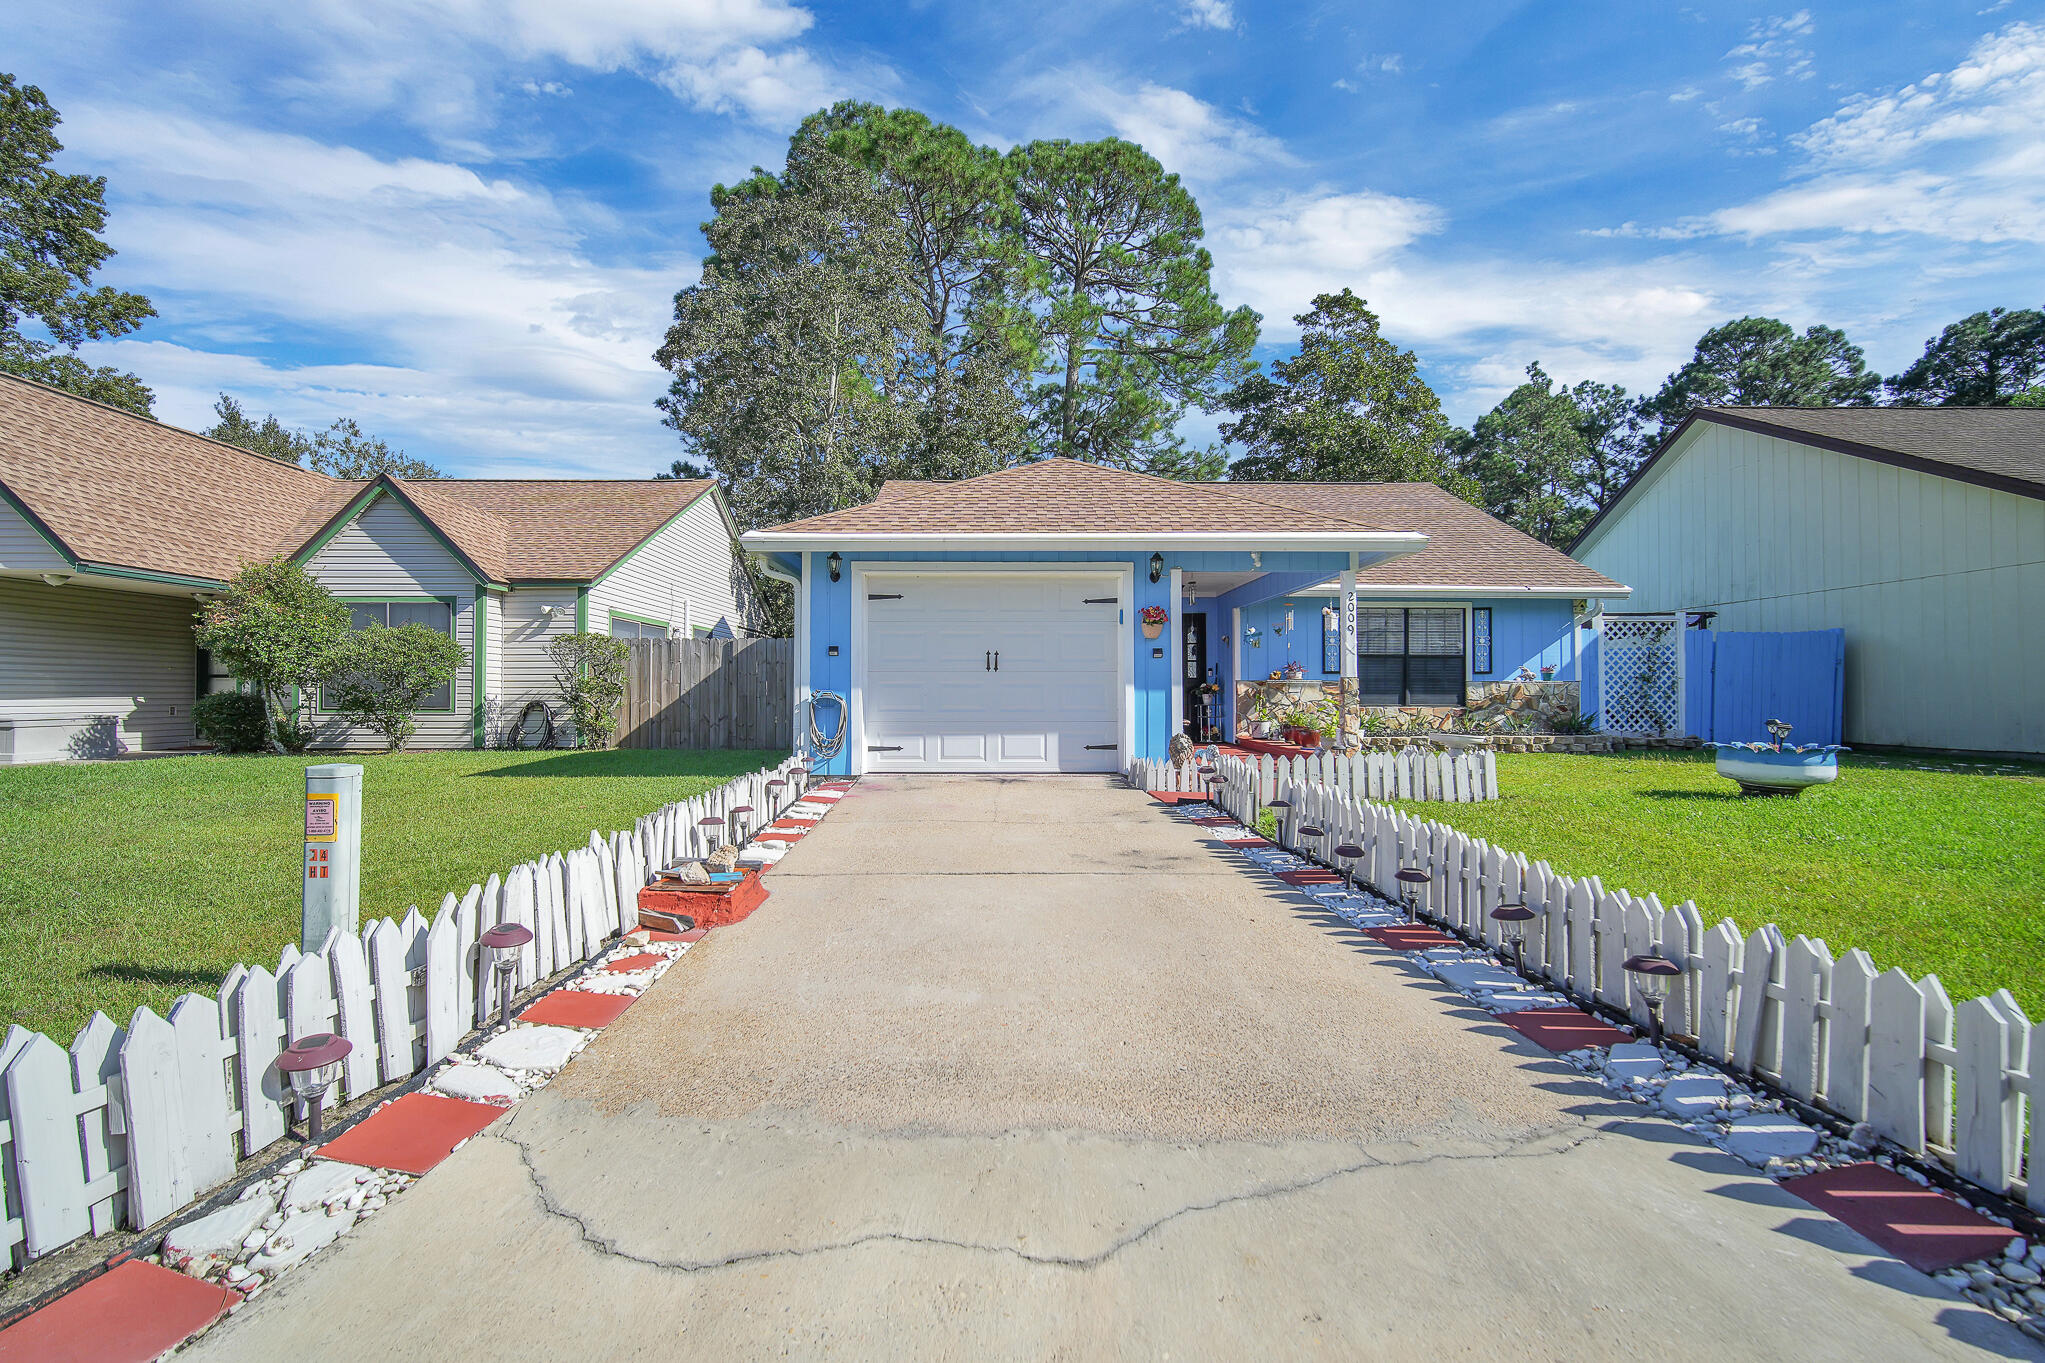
[0, 374, 716, 582]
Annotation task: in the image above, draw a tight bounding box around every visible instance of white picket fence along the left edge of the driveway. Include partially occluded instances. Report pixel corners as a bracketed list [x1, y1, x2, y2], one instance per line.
[0, 758, 800, 1267]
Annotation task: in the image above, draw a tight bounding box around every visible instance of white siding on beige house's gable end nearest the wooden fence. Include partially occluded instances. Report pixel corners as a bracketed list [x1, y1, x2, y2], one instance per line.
[589, 492, 753, 638]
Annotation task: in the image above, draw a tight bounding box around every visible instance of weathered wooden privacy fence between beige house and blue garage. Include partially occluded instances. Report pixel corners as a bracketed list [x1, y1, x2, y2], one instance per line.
[618, 640, 796, 748]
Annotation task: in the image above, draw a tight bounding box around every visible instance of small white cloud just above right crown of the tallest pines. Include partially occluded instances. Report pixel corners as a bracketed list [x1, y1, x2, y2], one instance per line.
[1025, 67, 1297, 180]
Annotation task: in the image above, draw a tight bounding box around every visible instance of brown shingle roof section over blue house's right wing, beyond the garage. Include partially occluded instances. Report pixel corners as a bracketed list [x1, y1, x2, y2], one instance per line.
[1233, 482, 1624, 597]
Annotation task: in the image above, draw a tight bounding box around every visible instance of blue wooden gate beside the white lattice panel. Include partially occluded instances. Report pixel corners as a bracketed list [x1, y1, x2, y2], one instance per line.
[1683, 629, 1847, 744]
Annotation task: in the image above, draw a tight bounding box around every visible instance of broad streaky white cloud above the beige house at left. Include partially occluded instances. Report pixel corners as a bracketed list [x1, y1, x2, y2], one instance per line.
[65, 104, 695, 474]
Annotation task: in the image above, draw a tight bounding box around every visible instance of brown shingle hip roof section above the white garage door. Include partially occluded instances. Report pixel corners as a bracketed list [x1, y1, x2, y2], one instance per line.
[773, 460, 1407, 535]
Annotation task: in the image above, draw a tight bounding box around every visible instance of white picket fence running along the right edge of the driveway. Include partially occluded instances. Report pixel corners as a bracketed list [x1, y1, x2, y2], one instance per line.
[1129, 758, 2045, 1212]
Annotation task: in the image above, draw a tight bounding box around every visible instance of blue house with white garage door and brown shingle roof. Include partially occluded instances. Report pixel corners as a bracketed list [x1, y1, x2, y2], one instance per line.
[742, 460, 1626, 774]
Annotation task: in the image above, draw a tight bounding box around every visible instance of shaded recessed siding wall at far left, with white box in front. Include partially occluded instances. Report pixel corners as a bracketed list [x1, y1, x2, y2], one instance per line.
[0, 576, 198, 762]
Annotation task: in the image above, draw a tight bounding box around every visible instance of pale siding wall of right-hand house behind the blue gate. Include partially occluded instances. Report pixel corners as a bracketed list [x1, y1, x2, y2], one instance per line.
[1577, 421, 2045, 752]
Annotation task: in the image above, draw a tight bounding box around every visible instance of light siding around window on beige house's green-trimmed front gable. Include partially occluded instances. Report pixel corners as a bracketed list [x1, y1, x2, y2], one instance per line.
[309, 497, 476, 748]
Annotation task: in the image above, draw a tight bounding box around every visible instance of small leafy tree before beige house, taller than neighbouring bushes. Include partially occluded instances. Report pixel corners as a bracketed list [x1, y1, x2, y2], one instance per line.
[198, 558, 348, 748]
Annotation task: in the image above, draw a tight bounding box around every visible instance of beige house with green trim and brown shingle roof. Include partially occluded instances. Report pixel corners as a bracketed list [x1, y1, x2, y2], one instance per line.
[0, 376, 755, 762]
